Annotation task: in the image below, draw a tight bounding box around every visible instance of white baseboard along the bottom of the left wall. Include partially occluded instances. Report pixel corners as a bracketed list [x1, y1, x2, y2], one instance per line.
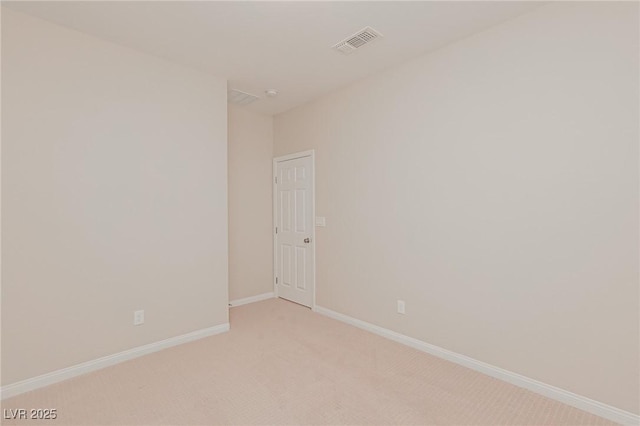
[0, 323, 229, 399]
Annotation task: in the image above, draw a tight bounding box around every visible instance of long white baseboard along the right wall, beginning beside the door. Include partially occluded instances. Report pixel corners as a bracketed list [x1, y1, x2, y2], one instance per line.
[313, 305, 640, 425]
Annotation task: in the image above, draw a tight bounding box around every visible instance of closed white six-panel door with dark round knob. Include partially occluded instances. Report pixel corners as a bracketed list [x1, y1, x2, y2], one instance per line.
[274, 154, 315, 307]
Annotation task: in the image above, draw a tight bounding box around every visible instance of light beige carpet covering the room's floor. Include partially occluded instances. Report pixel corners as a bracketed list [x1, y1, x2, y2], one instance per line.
[2, 299, 610, 425]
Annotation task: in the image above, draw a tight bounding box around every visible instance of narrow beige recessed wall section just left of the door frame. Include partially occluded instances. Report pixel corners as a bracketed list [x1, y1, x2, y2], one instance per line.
[229, 106, 273, 300]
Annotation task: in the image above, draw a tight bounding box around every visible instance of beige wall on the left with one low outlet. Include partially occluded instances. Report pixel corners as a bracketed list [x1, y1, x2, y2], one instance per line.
[2, 9, 228, 384]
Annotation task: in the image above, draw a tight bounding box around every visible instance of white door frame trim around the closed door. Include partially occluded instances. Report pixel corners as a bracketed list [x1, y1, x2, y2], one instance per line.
[271, 149, 316, 311]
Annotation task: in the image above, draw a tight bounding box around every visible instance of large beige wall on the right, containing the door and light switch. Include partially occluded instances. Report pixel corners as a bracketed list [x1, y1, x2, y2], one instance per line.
[274, 3, 640, 413]
